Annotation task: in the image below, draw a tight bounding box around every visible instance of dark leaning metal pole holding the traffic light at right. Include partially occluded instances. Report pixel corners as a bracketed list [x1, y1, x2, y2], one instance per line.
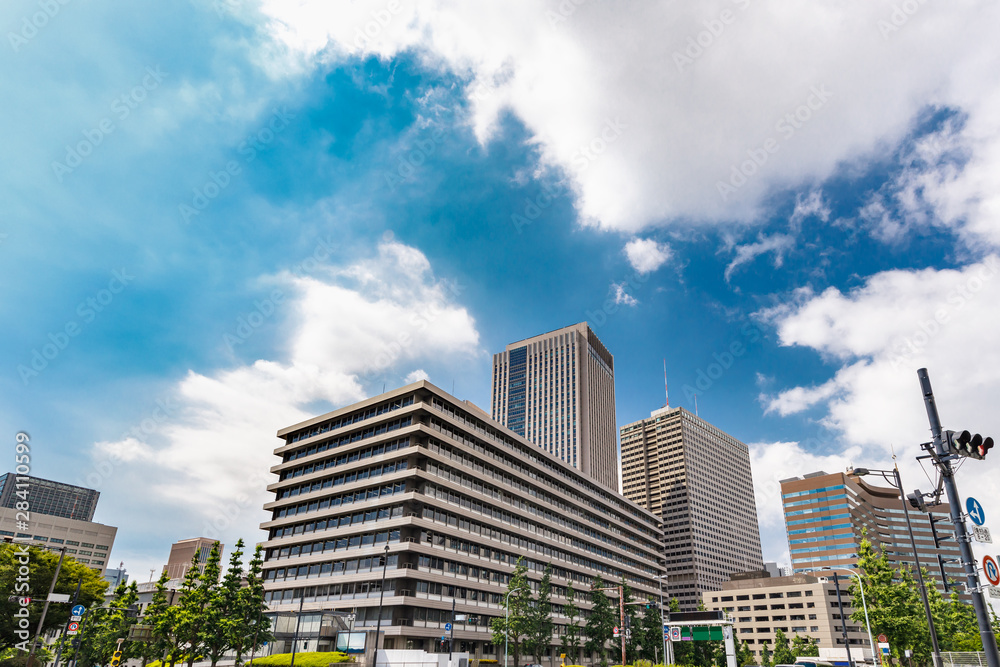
[917, 368, 1000, 667]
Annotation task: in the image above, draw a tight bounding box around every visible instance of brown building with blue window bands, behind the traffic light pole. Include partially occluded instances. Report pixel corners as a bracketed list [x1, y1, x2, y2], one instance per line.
[781, 471, 965, 593]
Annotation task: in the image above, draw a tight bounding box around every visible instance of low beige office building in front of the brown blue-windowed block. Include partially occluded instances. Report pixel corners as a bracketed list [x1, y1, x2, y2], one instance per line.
[702, 573, 871, 662]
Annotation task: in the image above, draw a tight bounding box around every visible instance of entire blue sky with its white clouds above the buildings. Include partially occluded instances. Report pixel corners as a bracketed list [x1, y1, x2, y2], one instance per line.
[0, 0, 1000, 588]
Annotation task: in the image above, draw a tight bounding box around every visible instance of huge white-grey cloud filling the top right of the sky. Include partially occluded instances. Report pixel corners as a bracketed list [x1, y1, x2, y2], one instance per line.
[262, 0, 1000, 231]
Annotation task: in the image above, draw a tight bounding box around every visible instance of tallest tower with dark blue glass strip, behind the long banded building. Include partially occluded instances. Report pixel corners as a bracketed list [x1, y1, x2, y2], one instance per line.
[490, 322, 618, 490]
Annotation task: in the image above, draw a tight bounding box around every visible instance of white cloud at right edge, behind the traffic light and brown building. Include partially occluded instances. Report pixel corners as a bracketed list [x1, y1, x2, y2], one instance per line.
[767, 256, 1000, 576]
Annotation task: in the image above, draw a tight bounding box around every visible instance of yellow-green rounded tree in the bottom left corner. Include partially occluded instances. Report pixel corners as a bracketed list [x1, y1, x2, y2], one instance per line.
[0, 542, 108, 651]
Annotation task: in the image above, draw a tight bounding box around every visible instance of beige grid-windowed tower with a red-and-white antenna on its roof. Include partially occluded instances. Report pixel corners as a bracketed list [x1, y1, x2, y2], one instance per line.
[621, 407, 764, 611]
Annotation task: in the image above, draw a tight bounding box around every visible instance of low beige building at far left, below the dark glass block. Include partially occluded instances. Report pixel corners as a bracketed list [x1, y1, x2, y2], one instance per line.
[0, 507, 118, 576]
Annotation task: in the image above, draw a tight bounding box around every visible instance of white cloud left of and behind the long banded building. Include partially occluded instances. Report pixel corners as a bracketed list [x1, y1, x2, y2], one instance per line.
[82, 241, 479, 560]
